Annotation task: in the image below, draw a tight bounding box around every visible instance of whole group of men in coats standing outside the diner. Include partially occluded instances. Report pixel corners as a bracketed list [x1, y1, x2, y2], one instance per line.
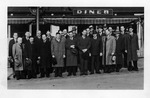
[9, 25, 139, 80]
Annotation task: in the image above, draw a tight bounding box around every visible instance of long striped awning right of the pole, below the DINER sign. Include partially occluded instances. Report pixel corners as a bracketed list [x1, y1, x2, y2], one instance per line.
[43, 18, 138, 24]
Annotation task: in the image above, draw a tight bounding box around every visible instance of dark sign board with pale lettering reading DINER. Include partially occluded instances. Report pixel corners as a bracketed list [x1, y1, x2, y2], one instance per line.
[73, 9, 113, 15]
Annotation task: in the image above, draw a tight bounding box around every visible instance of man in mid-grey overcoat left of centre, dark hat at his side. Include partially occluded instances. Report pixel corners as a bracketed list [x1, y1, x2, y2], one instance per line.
[51, 32, 66, 77]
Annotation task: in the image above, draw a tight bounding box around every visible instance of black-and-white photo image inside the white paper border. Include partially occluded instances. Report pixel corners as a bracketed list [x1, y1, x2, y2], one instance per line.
[7, 6, 144, 89]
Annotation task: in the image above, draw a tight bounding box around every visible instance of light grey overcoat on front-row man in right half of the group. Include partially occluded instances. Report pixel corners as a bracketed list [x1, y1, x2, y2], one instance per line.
[102, 36, 116, 65]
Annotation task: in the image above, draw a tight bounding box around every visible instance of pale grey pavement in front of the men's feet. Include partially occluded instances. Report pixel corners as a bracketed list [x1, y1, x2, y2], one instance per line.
[7, 58, 144, 90]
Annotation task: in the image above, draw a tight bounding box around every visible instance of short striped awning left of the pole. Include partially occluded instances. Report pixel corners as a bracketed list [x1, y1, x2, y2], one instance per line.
[8, 18, 35, 24]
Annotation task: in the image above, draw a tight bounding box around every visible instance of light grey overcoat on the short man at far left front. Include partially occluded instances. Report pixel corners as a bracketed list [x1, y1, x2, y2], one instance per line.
[12, 43, 23, 71]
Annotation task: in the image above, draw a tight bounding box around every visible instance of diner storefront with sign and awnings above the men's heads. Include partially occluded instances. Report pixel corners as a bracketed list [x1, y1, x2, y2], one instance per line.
[7, 7, 144, 55]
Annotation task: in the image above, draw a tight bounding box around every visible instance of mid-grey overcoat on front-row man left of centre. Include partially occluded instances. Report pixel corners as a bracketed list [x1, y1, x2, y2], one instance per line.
[51, 37, 66, 67]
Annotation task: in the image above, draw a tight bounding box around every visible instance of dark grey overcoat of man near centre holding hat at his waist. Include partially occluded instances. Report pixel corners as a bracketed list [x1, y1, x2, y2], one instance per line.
[66, 37, 77, 66]
